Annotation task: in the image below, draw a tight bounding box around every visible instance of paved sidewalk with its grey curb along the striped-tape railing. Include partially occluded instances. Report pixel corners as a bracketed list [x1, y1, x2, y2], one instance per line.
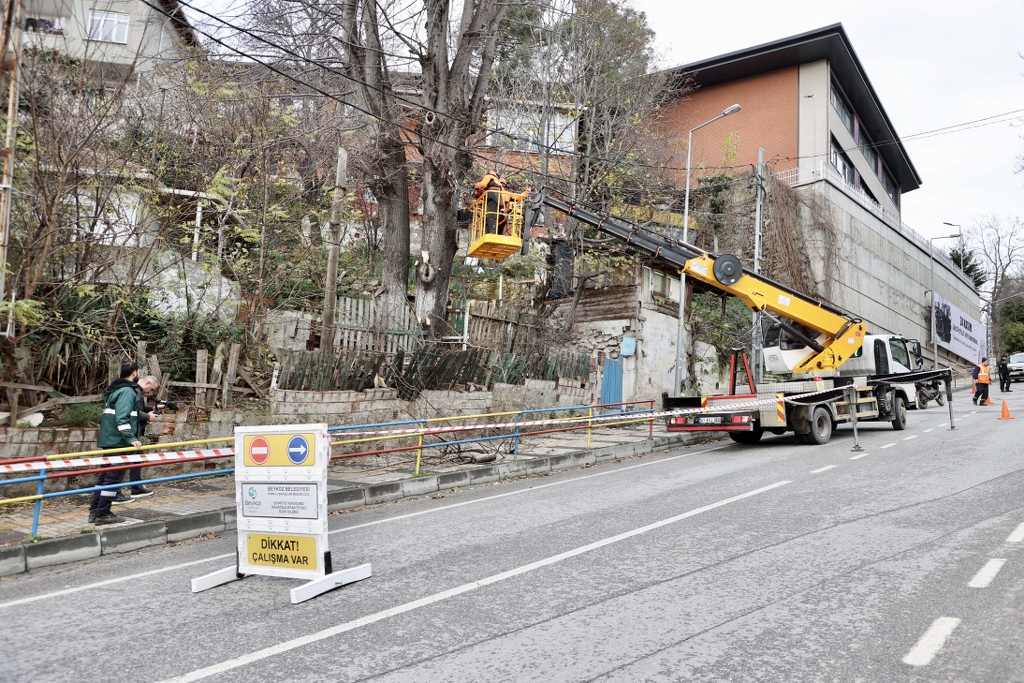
[0, 424, 713, 577]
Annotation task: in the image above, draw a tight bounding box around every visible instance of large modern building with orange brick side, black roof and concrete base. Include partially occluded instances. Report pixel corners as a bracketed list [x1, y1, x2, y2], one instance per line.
[663, 24, 981, 365]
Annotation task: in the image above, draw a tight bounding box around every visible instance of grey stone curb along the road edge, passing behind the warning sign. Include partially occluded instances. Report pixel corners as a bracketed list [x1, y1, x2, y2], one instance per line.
[0, 432, 721, 577]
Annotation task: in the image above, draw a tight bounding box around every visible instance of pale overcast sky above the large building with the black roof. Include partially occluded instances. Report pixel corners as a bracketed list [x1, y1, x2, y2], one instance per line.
[631, 0, 1024, 240]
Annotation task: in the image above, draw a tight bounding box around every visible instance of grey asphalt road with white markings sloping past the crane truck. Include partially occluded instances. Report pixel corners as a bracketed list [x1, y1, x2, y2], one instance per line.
[0, 391, 1024, 683]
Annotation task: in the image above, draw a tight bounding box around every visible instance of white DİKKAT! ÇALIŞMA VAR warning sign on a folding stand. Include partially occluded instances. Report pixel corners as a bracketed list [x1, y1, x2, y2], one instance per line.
[191, 424, 372, 604]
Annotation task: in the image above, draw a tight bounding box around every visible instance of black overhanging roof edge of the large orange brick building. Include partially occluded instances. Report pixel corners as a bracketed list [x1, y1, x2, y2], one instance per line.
[666, 24, 922, 193]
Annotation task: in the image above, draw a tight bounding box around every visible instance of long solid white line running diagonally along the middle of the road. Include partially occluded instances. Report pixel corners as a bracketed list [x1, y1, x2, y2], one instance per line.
[155, 480, 792, 683]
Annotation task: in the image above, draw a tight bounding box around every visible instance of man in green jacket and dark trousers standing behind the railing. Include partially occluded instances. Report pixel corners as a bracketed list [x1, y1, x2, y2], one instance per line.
[89, 362, 142, 524]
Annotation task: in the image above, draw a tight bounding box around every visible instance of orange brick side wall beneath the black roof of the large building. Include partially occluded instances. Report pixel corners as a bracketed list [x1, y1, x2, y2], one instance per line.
[658, 67, 800, 185]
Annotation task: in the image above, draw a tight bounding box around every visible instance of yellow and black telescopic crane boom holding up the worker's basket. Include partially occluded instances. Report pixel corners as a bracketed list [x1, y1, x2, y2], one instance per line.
[527, 191, 866, 373]
